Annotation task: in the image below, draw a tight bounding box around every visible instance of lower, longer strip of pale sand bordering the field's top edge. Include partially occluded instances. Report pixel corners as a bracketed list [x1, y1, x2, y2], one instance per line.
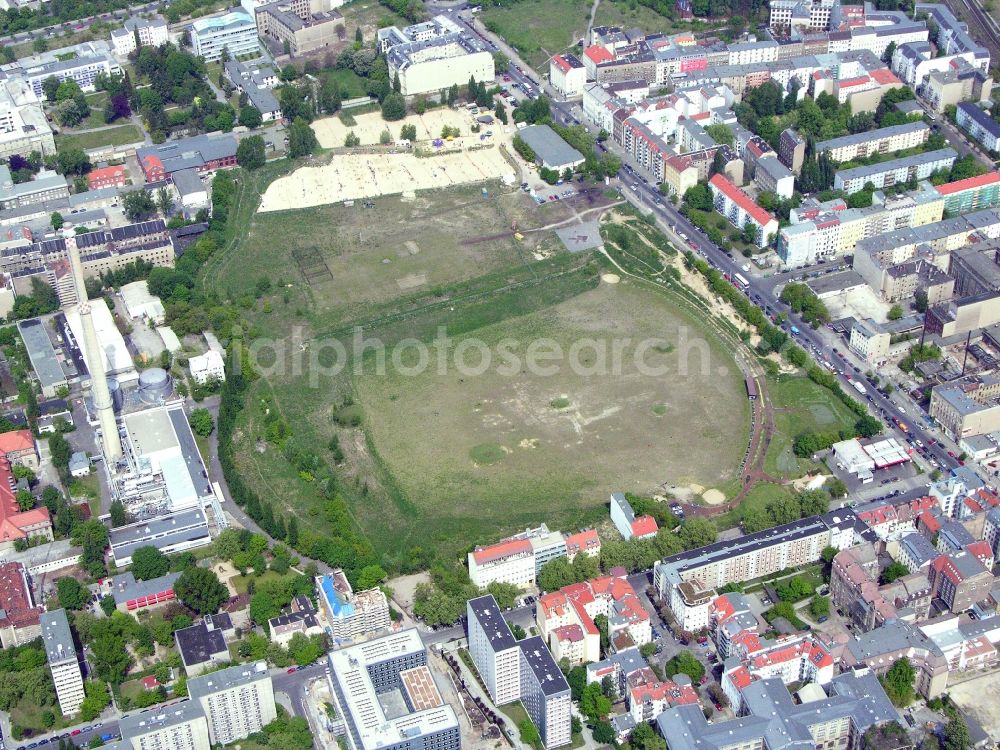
[258, 145, 514, 212]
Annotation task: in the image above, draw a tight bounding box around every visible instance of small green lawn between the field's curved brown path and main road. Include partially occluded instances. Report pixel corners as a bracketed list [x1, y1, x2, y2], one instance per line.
[764, 376, 857, 479]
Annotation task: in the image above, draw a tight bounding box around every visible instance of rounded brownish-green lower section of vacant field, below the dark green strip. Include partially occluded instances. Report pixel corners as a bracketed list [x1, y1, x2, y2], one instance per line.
[355, 283, 748, 552]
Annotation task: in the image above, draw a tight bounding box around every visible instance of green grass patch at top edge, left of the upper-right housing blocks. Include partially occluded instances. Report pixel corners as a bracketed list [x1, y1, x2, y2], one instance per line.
[480, 0, 591, 66]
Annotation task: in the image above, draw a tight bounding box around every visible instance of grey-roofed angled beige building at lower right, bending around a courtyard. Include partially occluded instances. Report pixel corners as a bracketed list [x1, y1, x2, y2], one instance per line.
[841, 620, 948, 698]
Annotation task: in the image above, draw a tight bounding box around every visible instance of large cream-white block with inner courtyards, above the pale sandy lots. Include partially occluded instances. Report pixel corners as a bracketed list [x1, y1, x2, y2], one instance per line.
[378, 15, 496, 96]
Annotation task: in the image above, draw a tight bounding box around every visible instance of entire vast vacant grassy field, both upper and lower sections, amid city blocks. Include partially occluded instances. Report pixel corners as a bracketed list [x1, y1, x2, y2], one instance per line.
[219, 178, 749, 563]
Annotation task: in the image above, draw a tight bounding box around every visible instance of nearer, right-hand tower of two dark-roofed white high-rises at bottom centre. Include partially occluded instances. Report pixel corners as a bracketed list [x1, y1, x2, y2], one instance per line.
[518, 635, 573, 750]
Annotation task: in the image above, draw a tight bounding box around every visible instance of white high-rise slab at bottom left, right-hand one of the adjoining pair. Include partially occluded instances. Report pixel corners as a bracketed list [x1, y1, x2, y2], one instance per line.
[188, 662, 278, 745]
